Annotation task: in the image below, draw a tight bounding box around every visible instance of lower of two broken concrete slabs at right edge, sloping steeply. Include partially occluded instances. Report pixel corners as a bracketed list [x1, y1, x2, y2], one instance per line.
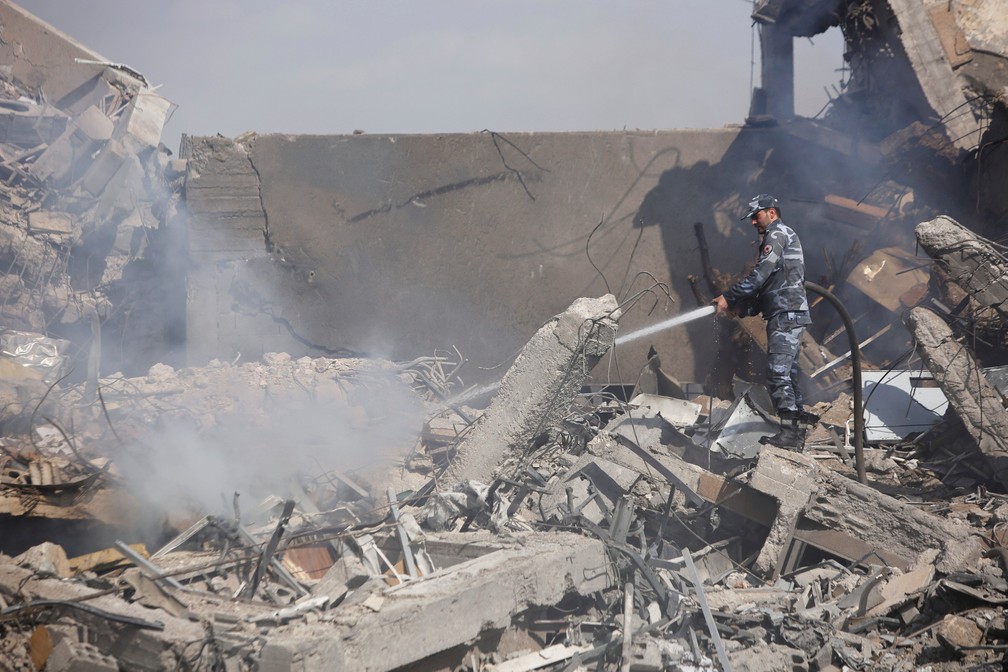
[907, 306, 1008, 484]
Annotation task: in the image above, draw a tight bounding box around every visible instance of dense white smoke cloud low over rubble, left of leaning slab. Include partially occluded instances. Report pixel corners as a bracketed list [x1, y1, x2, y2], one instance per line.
[110, 360, 423, 514]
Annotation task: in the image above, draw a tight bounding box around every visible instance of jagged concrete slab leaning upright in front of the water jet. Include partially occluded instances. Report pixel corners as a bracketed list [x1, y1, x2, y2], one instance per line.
[444, 294, 620, 483]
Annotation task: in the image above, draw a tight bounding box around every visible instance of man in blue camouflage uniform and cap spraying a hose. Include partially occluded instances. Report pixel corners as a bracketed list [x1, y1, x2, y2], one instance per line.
[712, 193, 813, 449]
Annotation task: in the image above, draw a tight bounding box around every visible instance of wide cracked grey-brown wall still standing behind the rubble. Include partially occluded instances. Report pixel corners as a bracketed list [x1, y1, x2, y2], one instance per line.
[182, 128, 912, 383]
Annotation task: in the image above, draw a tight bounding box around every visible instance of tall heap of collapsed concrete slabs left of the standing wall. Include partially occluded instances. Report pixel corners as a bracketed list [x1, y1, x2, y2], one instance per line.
[0, 46, 185, 375]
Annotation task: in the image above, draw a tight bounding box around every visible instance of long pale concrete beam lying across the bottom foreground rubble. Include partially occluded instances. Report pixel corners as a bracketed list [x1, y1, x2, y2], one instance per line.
[258, 532, 613, 672]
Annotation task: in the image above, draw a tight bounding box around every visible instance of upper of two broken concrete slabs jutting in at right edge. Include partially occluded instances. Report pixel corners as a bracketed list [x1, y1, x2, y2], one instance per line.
[914, 215, 1008, 317]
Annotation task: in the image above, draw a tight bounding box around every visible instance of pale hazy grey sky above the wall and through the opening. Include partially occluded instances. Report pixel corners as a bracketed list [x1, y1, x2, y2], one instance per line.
[16, 0, 843, 150]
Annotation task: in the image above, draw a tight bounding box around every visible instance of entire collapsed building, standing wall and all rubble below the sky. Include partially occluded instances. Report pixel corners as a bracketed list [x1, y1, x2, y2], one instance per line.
[0, 0, 1008, 672]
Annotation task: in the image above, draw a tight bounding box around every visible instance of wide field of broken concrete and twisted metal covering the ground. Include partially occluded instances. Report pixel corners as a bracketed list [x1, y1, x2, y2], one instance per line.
[0, 276, 1008, 670]
